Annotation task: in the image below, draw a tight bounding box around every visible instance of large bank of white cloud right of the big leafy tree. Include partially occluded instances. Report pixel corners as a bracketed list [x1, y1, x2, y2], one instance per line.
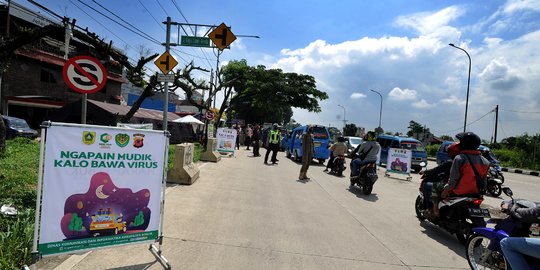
[258, 1, 540, 139]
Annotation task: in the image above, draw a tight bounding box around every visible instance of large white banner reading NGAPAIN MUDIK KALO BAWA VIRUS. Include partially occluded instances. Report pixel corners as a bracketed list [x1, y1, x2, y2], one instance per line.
[38, 124, 166, 256]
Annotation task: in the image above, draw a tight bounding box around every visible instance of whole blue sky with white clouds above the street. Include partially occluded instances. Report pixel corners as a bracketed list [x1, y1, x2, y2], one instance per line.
[8, 0, 540, 141]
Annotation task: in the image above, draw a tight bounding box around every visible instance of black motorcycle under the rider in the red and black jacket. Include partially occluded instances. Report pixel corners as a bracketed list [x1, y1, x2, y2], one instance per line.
[414, 168, 491, 244]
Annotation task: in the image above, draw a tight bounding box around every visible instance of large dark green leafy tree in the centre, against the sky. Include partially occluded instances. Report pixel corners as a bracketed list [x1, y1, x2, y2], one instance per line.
[223, 59, 328, 123]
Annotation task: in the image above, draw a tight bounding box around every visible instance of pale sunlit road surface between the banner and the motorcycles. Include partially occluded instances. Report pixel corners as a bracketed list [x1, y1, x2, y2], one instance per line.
[40, 149, 540, 270]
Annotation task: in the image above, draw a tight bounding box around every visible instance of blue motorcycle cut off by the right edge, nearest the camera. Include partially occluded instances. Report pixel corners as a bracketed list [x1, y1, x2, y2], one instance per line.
[466, 187, 540, 270]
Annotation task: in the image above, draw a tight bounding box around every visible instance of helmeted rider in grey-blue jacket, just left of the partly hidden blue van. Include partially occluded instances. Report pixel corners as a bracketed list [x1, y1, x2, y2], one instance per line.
[351, 131, 381, 177]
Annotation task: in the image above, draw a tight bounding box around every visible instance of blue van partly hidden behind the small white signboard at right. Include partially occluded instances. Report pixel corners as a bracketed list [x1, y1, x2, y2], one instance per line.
[377, 134, 427, 172]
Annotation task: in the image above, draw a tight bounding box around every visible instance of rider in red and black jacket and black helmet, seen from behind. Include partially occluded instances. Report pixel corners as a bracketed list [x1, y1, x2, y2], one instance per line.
[441, 132, 490, 207]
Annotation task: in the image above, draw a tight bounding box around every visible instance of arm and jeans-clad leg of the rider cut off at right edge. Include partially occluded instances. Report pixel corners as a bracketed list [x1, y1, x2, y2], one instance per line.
[500, 204, 540, 269]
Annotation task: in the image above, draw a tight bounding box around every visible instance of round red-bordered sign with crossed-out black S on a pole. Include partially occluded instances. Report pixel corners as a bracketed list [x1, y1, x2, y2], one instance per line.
[62, 55, 107, 94]
